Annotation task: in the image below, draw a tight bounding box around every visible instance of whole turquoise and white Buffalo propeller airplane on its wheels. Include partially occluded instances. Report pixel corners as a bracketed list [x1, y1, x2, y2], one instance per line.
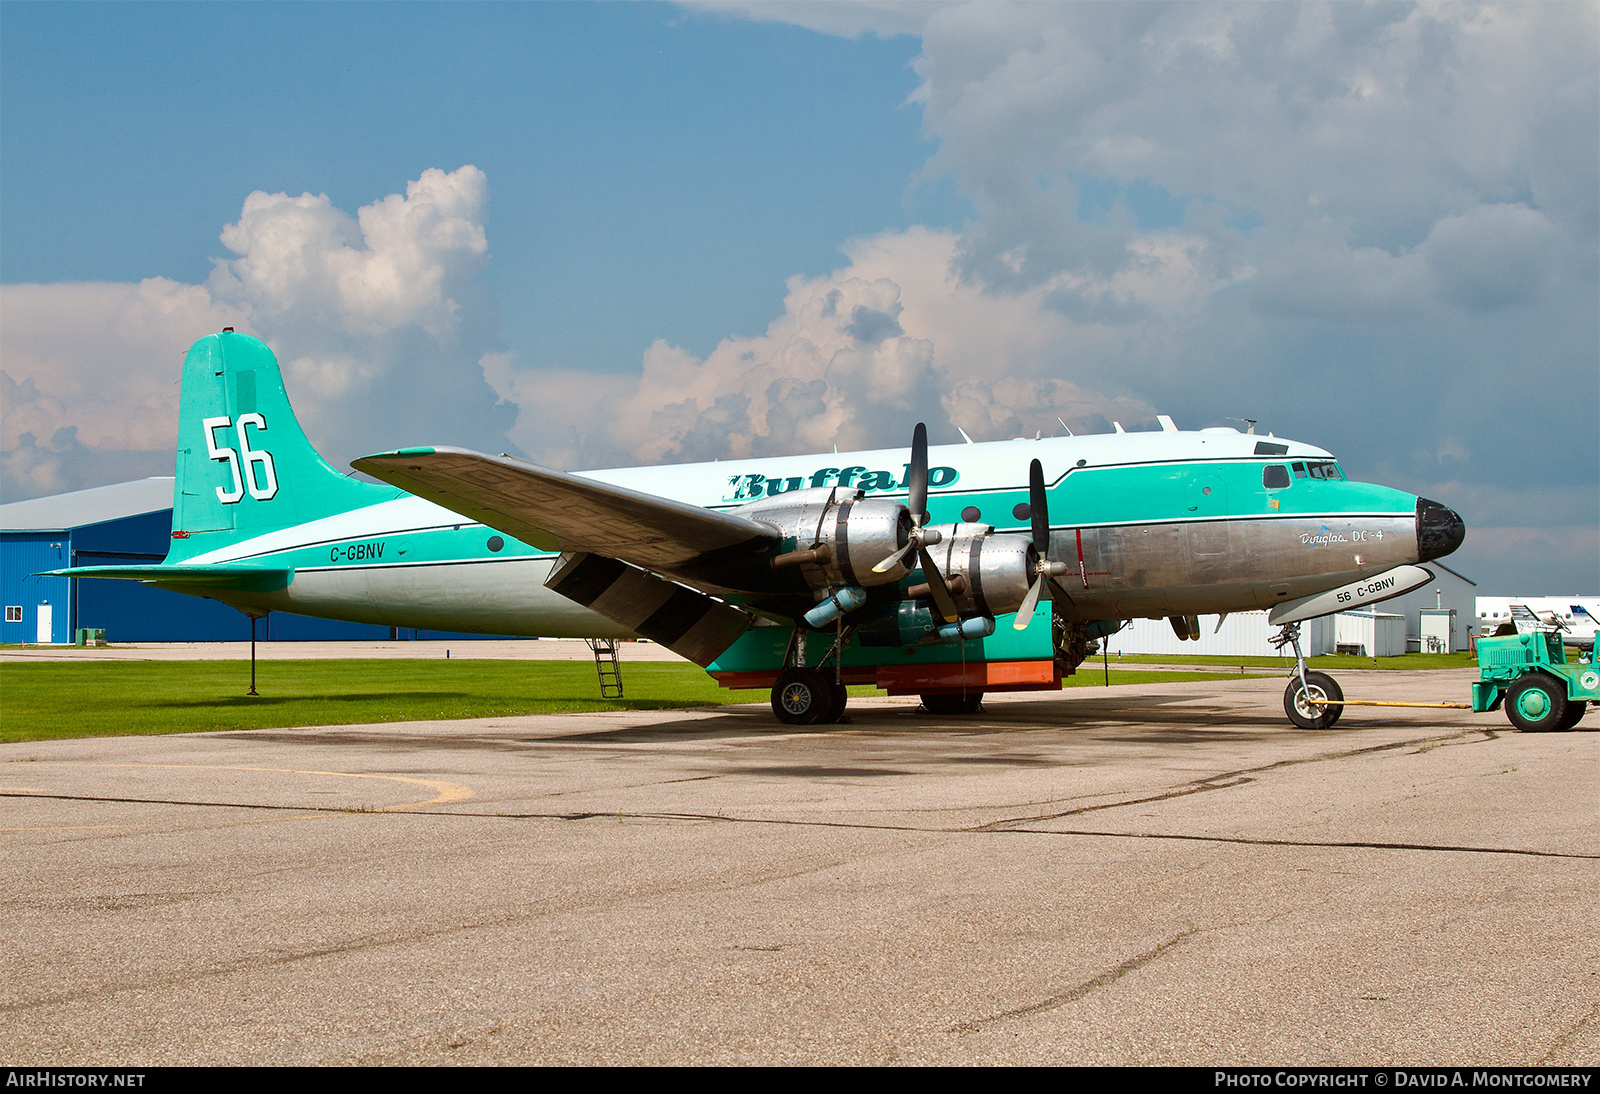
[56, 329, 1464, 728]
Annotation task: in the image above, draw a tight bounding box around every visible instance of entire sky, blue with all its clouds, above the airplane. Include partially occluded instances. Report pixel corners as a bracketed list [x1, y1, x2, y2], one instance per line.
[0, 2, 1600, 593]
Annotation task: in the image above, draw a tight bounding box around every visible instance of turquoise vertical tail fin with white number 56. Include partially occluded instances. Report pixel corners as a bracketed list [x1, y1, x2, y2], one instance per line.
[166, 329, 395, 561]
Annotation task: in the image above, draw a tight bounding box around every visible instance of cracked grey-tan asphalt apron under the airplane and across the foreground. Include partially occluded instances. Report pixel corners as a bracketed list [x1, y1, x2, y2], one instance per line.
[0, 662, 1600, 1067]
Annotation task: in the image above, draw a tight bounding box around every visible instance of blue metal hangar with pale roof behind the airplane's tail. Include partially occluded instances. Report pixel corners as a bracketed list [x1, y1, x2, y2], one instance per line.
[0, 478, 486, 643]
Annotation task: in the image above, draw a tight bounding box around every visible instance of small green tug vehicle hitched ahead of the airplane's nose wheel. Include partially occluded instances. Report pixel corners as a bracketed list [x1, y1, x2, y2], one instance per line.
[1472, 630, 1600, 733]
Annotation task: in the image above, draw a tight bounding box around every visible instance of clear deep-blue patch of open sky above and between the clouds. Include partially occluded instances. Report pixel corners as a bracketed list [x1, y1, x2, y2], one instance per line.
[0, 3, 962, 369]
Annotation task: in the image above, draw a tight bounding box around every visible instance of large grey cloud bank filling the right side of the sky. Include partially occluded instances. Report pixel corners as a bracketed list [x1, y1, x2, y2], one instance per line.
[656, 3, 1600, 585]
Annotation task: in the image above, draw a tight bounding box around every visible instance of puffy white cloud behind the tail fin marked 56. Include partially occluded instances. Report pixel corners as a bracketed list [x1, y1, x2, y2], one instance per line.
[0, 165, 512, 499]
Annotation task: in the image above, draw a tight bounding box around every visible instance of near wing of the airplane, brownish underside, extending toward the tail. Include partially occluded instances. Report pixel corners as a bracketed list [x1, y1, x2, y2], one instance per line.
[350, 448, 779, 574]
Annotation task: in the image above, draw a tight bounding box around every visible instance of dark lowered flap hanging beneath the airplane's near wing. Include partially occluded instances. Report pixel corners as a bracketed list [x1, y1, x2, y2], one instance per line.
[544, 553, 755, 669]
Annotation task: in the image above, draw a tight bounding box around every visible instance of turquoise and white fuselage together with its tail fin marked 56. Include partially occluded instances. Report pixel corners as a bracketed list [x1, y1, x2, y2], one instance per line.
[67, 331, 1459, 637]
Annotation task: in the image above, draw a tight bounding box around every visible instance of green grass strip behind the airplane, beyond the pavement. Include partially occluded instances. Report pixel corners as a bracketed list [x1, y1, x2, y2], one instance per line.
[0, 659, 1237, 742]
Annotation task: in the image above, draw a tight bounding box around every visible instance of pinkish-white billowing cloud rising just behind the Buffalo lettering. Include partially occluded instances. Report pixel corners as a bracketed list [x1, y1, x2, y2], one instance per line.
[486, 229, 1174, 467]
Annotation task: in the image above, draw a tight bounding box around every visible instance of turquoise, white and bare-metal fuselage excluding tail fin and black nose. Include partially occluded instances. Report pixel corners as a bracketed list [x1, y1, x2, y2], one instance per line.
[175, 430, 1416, 637]
